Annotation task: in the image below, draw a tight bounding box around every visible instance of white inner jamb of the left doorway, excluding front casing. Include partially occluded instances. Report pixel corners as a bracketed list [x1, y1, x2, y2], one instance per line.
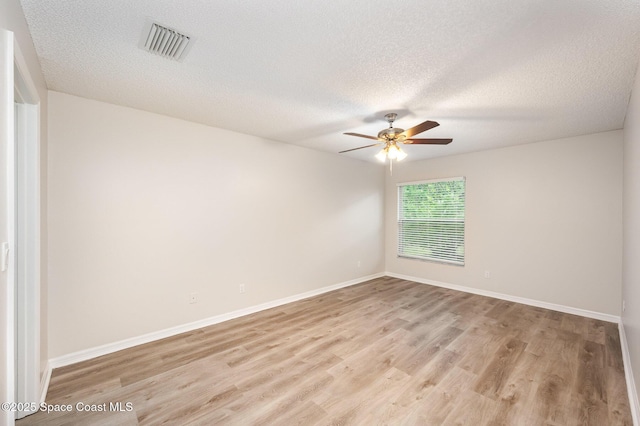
[14, 33, 42, 418]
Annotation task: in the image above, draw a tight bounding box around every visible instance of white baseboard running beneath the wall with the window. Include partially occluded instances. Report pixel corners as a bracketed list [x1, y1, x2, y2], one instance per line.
[385, 272, 620, 323]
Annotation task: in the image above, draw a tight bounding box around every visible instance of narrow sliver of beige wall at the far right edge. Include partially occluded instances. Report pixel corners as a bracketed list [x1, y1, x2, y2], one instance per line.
[622, 55, 640, 414]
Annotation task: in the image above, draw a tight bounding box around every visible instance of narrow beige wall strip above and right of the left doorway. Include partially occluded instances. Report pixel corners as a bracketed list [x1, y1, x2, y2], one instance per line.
[0, 0, 48, 380]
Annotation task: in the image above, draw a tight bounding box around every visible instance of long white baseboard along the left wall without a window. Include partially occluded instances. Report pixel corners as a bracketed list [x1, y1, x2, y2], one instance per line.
[45, 272, 384, 370]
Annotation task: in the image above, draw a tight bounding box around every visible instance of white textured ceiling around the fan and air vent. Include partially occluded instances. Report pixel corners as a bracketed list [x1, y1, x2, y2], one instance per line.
[17, 0, 640, 161]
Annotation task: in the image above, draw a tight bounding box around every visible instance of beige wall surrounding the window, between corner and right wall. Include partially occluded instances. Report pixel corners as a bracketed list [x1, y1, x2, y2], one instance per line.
[386, 131, 622, 315]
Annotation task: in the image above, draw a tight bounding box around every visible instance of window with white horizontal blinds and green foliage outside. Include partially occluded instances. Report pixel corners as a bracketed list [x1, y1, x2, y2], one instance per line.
[398, 177, 465, 265]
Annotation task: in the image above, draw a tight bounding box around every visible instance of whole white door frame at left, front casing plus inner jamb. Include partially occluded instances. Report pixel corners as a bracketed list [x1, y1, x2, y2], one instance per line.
[0, 29, 41, 425]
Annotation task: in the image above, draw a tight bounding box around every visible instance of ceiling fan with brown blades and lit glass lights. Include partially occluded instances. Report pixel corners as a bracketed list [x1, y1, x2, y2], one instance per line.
[339, 113, 453, 166]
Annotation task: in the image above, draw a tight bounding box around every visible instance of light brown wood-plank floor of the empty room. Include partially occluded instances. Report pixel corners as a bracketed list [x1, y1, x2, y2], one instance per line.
[17, 277, 632, 426]
